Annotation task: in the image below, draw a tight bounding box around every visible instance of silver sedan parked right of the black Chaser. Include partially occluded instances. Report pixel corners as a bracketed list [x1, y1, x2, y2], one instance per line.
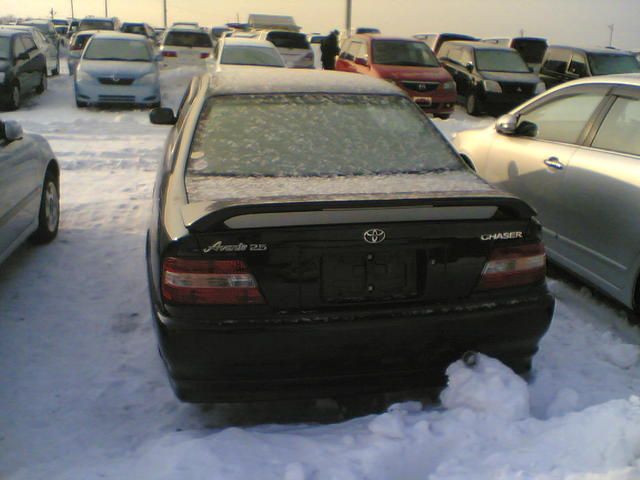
[454, 74, 640, 312]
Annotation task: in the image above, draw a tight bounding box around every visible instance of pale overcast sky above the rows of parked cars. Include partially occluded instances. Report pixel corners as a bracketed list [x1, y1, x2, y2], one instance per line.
[5, 0, 640, 50]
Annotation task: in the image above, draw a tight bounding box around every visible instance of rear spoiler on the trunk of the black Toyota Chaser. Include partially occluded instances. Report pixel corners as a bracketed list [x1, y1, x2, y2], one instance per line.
[182, 191, 536, 233]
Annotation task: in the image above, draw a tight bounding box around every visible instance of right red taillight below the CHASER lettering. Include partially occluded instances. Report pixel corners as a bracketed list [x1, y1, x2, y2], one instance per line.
[477, 243, 547, 290]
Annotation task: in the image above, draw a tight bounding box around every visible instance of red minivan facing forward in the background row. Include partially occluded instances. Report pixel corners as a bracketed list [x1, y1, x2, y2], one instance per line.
[336, 35, 456, 118]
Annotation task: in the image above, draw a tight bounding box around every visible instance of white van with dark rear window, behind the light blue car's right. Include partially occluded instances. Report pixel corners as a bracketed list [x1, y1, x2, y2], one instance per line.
[160, 27, 213, 67]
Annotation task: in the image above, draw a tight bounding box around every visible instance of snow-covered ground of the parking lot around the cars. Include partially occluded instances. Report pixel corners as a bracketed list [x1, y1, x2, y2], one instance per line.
[0, 64, 640, 480]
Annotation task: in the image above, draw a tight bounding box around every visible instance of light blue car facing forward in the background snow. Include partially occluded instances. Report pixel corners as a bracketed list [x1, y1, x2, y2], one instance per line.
[74, 32, 160, 107]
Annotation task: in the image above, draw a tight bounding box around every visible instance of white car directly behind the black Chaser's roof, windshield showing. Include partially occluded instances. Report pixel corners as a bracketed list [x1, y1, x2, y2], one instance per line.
[216, 37, 285, 68]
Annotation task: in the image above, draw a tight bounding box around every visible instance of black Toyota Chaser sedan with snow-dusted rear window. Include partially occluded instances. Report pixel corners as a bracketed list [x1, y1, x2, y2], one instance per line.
[147, 68, 554, 402]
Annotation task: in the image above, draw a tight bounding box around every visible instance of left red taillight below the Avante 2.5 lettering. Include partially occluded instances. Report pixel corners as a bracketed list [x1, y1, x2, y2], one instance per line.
[162, 257, 264, 305]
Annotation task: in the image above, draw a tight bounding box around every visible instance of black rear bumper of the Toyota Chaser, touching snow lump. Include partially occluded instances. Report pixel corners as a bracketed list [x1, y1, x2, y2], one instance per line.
[154, 293, 554, 402]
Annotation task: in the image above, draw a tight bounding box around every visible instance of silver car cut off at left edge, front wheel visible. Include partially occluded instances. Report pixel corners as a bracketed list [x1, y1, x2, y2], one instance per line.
[0, 121, 60, 262]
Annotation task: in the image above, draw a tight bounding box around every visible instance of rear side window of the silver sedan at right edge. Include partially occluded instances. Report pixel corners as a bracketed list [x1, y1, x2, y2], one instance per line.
[592, 98, 640, 155]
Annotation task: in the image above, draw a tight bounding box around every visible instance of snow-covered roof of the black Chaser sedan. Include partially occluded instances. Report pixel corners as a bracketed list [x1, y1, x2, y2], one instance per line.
[210, 67, 405, 96]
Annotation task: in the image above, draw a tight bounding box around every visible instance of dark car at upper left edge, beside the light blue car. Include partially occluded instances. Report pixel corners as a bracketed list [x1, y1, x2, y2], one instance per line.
[0, 30, 47, 110]
